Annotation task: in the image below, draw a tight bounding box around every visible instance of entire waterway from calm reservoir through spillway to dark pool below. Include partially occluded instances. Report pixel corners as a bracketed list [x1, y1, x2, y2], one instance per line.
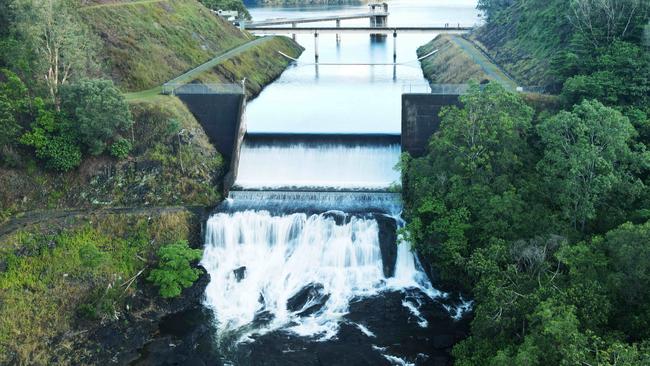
[135, 0, 480, 365]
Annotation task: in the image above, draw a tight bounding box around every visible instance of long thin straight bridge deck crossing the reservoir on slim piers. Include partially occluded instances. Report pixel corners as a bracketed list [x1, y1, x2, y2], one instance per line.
[246, 26, 472, 34]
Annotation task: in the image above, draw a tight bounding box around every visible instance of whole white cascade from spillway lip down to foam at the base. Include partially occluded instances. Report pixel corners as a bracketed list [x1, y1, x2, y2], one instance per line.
[202, 134, 460, 350]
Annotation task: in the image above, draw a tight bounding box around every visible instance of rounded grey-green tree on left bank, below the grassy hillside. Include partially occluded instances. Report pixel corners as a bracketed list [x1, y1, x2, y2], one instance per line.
[61, 80, 133, 155]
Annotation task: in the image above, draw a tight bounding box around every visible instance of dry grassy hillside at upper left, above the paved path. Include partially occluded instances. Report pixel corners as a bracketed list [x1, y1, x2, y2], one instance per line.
[80, 0, 251, 91]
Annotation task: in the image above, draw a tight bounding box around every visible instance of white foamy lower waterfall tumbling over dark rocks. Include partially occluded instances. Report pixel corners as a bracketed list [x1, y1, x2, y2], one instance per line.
[201, 211, 440, 339]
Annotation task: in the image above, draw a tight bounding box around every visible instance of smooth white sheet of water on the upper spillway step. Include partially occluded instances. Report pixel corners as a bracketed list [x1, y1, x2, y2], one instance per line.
[235, 142, 401, 190]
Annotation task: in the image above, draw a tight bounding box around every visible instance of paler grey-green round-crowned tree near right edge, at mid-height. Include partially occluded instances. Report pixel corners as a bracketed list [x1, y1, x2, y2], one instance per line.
[537, 101, 641, 232]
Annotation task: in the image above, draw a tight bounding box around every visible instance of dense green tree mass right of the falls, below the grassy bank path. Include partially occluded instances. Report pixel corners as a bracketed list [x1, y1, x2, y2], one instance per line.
[403, 83, 650, 365]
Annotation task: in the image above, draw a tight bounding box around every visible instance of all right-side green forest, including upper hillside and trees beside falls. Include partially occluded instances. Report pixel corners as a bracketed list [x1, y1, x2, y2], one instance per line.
[401, 0, 650, 365]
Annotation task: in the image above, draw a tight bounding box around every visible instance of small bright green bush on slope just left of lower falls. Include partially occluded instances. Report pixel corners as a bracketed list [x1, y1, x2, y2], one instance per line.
[147, 240, 201, 298]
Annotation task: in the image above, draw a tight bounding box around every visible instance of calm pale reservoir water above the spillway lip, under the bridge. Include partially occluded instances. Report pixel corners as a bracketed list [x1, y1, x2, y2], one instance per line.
[240, 0, 481, 134]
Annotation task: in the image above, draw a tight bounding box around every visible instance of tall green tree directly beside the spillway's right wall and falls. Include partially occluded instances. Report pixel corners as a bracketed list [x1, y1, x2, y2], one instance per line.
[404, 83, 532, 286]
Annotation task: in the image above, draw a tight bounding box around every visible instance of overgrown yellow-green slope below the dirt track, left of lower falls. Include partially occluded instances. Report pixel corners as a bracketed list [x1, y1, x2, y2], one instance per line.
[0, 208, 200, 365]
